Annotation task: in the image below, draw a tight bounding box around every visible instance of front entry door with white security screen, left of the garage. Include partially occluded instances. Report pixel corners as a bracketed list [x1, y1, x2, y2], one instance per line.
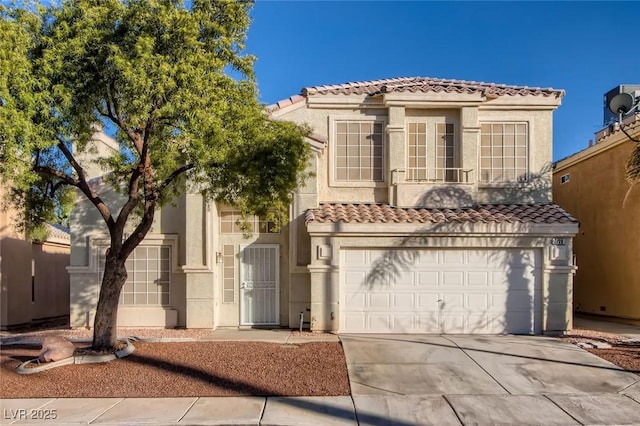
[240, 244, 280, 325]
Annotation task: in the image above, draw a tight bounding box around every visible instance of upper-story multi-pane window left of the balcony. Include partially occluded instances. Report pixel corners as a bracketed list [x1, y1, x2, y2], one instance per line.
[334, 121, 384, 182]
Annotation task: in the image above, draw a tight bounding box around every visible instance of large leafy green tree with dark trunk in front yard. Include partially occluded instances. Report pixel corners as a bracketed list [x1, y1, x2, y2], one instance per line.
[0, 0, 309, 349]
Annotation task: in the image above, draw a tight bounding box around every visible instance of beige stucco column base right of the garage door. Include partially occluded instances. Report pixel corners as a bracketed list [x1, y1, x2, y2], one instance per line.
[542, 266, 575, 334]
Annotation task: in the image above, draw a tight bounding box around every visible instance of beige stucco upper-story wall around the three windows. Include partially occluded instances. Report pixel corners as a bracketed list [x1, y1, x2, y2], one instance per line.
[275, 94, 559, 207]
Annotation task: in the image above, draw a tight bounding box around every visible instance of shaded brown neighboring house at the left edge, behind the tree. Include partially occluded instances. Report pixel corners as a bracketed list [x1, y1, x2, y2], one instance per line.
[0, 188, 70, 330]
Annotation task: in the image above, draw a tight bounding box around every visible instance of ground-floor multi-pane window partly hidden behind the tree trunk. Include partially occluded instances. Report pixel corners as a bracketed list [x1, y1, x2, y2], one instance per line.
[98, 245, 171, 306]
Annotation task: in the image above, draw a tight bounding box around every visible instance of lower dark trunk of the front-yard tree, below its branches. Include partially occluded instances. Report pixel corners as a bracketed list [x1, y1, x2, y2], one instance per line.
[91, 253, 127, 351]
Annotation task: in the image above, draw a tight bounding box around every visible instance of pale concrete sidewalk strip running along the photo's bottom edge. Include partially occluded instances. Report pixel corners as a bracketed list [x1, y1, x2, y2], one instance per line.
[0, 389, 640, 426]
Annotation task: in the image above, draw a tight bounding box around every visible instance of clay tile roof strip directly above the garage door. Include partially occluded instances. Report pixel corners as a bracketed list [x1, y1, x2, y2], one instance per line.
[305, 204, 578, 224]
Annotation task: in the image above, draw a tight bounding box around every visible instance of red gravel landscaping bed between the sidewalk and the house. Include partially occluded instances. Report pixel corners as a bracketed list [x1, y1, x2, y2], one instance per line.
[0, 341, 349, 398]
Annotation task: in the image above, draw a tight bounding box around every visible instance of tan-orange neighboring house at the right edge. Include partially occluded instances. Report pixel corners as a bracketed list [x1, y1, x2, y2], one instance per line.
[553, 110, 640, 321]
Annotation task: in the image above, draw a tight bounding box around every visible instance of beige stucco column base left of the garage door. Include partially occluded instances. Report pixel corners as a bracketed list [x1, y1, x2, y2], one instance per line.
[308, 265, 339, 332]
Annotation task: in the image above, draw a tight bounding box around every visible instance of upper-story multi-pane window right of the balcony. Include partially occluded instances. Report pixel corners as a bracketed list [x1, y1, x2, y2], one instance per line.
[480, 123, 529, 182]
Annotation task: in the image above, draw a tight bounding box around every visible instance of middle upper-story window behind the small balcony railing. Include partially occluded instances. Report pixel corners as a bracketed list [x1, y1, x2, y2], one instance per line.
[406, 123, 461, 182]
